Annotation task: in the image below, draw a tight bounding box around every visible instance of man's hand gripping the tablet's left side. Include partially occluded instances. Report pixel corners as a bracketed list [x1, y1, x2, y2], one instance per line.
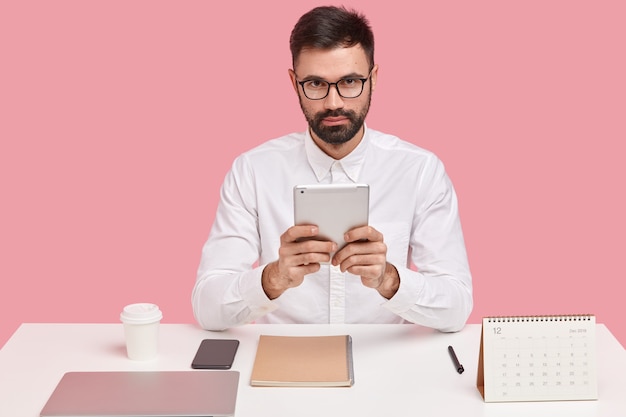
[261, 225, 337, 300]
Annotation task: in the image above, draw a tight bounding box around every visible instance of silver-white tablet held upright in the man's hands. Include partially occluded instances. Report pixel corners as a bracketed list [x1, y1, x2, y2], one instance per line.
[293, 184, 369, 258]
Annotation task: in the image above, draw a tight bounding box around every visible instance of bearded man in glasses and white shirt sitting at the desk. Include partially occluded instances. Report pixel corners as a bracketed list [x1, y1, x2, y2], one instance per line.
[192, 7, 472, 331]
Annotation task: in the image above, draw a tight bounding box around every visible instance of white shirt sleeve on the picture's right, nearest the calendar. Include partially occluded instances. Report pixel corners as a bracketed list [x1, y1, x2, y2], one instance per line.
[378, 156, 473, 331]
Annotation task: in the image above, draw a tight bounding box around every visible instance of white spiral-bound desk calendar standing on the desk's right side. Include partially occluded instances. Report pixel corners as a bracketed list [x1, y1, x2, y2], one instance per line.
[476, 314, 598, 402]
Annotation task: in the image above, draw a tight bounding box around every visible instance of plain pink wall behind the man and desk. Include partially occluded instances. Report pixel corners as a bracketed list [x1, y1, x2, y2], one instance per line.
[0, 0, 626, 345]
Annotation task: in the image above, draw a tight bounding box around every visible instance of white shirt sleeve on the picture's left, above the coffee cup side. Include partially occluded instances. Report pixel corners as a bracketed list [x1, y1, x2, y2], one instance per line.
[192, 158, 277, 330]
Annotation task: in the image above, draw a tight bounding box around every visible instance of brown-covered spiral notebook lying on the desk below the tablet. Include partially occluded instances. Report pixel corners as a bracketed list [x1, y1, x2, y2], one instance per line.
[250, 335, 354, 387]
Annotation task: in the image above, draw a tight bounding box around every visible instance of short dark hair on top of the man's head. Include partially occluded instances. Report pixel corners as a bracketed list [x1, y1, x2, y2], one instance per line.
[289, 6, 374, 68]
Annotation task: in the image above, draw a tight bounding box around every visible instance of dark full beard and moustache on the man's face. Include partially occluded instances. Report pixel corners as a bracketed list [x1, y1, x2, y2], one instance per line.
[300, 89, 372, 145]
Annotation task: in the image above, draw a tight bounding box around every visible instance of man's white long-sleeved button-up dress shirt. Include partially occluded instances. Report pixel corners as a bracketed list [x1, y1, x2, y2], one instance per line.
[192, 127, 473, 331]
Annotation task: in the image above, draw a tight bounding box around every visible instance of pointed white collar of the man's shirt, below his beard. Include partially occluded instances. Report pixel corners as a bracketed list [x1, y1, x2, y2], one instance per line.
[304, 124, 369, 182]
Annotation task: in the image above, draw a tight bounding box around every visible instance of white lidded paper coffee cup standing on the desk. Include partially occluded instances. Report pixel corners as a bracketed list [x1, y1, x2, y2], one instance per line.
[120, 303, 163, 361]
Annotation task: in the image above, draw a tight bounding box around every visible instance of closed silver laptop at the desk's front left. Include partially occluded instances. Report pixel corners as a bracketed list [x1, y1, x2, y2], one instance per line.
[40, 370, 239, 417]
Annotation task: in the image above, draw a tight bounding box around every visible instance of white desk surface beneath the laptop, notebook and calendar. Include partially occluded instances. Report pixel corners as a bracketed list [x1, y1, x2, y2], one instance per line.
[0, 324, 626, 417]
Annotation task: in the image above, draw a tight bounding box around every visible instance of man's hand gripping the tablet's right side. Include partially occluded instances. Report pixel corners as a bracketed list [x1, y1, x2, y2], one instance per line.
[332, 226, 400, 299]
